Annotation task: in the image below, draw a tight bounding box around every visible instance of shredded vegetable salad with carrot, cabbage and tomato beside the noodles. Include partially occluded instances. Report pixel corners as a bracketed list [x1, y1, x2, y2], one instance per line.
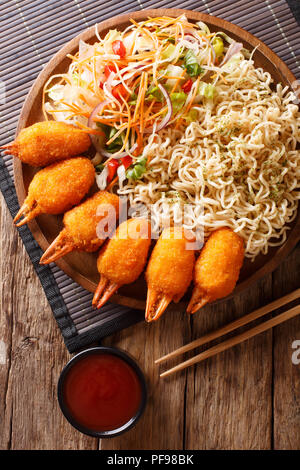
[43, 15, 243, 189]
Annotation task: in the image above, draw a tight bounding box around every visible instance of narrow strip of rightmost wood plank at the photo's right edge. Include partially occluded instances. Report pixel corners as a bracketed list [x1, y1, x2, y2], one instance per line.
[273, 245, 300, 450]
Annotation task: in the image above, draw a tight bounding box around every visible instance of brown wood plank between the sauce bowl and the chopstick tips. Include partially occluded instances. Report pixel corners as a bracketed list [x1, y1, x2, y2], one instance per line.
[101, 312, 190, 450]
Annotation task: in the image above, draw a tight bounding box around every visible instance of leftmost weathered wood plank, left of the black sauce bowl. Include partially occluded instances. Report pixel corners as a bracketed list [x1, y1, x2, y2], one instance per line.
[0, 196, 98, 449]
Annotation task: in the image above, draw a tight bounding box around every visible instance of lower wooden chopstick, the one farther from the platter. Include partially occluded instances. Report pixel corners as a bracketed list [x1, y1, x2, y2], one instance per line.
[160, 305, 300, 377]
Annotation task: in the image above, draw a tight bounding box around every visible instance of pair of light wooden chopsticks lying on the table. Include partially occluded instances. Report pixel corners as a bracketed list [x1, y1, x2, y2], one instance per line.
[155, 289, 300, 377]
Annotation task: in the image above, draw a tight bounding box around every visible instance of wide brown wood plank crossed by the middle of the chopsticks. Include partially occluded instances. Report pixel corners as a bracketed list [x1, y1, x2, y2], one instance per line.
[185, 276, 272, 449]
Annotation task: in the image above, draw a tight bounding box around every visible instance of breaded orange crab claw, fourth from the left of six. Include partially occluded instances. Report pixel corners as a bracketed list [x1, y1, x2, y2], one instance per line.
[93, 219, 151, 308]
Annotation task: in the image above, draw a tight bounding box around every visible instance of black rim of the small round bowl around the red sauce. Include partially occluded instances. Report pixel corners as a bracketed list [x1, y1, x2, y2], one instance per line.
[57, 346, 147, 439]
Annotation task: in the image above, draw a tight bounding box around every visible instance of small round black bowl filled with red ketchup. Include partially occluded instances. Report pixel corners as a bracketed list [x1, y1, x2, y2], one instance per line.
[57, 346, 147, 438]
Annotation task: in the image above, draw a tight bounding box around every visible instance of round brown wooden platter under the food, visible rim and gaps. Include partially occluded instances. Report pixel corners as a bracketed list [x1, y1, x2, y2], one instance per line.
[14, 9, 300, 311]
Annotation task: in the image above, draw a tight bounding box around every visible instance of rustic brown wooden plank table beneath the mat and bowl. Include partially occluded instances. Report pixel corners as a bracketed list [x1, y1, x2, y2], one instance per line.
[0, 193, 300, 450]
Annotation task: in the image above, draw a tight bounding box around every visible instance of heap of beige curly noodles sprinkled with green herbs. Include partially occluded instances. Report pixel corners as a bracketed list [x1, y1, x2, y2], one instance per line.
[118, 58, 300, 260]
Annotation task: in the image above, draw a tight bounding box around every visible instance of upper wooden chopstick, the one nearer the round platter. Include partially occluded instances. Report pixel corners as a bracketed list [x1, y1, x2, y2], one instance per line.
[155, 288, 300, 364]
